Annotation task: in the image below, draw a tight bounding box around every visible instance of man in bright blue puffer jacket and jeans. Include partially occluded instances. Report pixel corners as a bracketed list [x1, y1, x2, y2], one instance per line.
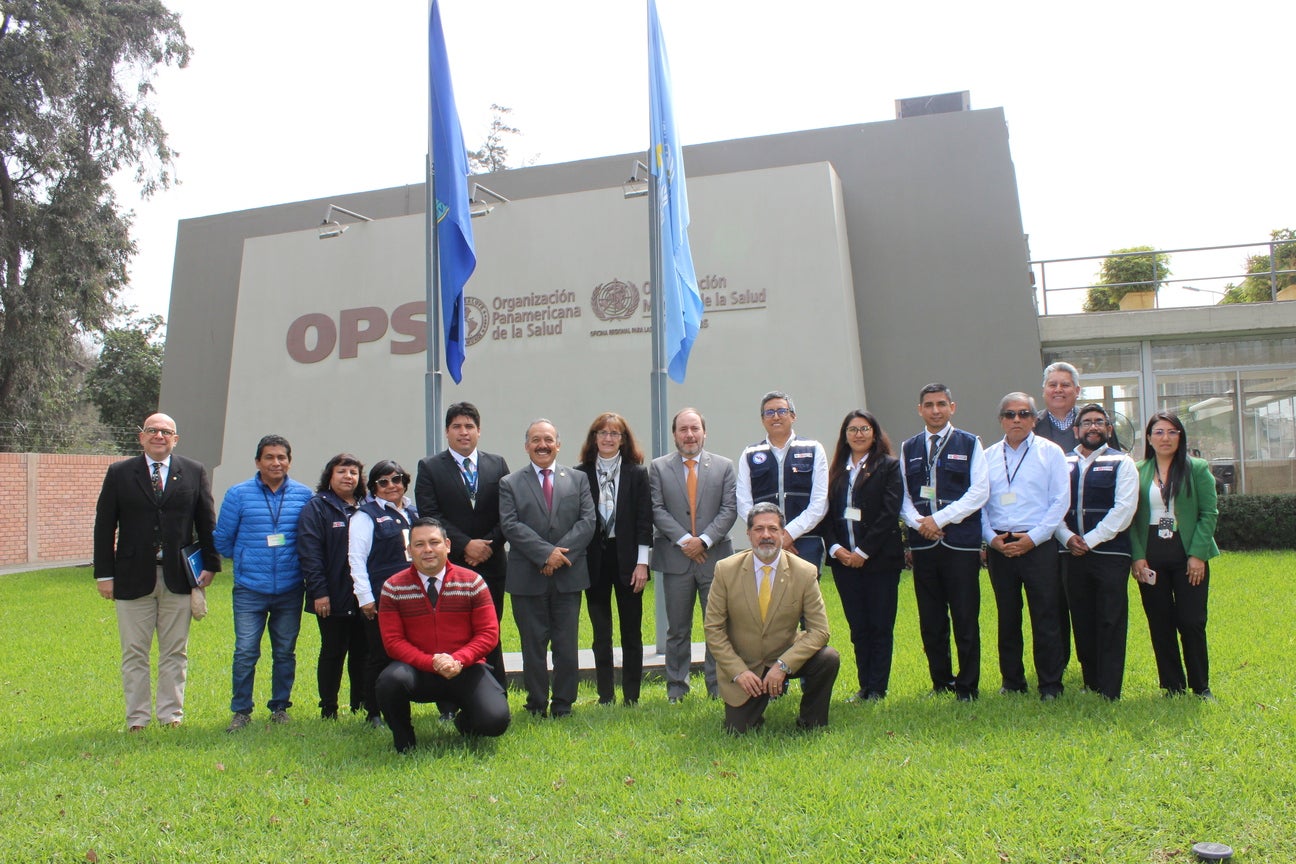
[215, 435, 311, 732]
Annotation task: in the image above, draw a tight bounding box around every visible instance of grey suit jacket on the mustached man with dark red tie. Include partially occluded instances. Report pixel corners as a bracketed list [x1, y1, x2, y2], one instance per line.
[499, 461, 595, 596]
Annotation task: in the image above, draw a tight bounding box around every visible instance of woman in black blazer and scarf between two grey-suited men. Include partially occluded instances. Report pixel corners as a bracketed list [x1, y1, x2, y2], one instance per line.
[577, 412, 652, 705]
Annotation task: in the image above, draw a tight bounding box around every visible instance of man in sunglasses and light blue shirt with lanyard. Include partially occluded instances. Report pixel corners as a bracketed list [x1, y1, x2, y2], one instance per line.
[981, 392, 1070, 701]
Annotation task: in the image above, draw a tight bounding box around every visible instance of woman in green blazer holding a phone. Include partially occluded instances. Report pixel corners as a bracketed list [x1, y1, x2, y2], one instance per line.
[1130, 411, 1220, 699]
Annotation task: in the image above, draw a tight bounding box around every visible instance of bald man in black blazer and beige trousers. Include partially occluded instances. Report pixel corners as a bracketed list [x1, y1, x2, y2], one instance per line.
[95, 413, 220, 732]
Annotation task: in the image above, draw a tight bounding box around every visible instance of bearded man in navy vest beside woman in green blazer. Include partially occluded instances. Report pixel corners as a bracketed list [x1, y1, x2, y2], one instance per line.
[1055, 404, 1138, 699]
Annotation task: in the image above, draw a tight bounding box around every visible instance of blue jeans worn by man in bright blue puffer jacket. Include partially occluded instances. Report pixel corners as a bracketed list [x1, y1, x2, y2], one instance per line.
[229, 583, 306, 714]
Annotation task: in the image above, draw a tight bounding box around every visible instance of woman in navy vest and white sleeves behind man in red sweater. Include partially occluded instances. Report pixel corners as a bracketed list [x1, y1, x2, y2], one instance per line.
[347, 459, 419, 728]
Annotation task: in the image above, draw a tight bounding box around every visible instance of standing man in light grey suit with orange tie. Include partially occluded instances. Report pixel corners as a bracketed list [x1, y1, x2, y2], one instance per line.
[648, 408, 737, 702]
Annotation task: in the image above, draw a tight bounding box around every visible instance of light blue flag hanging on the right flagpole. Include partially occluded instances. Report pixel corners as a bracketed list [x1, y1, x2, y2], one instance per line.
[648, 0, 702, 383]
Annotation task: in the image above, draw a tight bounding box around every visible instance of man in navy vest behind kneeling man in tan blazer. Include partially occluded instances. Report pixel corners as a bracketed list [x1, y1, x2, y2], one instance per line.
[736, 390, 828, 573]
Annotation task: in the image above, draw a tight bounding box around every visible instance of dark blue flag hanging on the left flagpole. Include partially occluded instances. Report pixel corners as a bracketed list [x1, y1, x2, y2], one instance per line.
[428, 0, 477, 383]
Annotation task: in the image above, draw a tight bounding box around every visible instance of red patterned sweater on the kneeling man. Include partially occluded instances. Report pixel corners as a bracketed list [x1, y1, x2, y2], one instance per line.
[378, 561, 499, 672]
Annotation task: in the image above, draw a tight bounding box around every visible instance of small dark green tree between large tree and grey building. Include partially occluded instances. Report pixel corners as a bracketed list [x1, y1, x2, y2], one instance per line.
[86, 310, 165, 453]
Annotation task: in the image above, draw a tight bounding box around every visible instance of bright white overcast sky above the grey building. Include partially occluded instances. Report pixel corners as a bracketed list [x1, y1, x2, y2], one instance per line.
[122, 0, 1296, 315]
